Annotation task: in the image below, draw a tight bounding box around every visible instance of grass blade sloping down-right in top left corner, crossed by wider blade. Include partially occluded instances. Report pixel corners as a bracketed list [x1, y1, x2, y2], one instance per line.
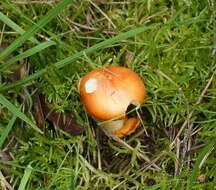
[0, 12, 39, 44]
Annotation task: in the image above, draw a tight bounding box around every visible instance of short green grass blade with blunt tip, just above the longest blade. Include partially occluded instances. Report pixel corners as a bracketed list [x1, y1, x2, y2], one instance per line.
[0, 41, 56, 68]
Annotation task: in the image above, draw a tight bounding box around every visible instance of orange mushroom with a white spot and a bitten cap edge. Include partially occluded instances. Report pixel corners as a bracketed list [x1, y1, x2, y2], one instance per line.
[79, 66, 146, 138]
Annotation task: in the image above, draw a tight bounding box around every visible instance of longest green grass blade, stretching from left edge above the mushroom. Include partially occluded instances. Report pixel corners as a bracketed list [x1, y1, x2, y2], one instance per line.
[0, 19, 205, 92]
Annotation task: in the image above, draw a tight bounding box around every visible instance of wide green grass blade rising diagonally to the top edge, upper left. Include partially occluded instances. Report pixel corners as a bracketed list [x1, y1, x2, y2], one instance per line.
[0, 0, 71, 60]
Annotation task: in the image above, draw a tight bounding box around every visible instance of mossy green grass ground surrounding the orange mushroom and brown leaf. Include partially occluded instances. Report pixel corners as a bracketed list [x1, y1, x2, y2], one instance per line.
[0, 0, 216, 190]
